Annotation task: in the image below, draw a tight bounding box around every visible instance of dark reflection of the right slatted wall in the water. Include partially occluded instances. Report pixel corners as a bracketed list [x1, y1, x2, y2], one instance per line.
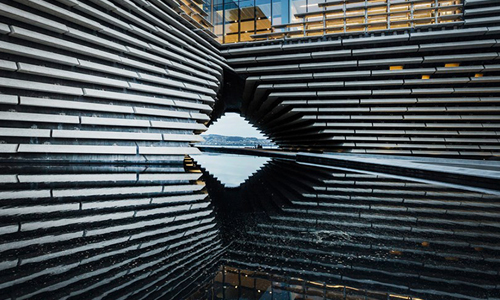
[190, 159, 500, 299]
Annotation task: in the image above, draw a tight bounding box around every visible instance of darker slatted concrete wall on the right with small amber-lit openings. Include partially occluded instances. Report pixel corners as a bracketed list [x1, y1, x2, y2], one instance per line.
[222, 1, 500, 157]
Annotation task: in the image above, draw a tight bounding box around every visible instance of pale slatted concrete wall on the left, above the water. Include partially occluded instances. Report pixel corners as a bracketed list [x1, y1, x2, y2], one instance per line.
[0, 0, 227, 162]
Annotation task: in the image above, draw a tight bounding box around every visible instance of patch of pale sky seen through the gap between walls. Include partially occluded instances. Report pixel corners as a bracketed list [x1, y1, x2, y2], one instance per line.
[204, 113, 266, 139]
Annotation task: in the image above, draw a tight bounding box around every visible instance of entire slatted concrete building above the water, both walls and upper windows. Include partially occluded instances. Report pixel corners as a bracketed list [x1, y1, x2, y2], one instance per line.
[0, 0, 500, 161]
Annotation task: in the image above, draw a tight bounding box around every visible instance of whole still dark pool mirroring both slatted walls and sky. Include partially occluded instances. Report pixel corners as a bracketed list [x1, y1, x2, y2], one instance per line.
[0, 154, 500, 300]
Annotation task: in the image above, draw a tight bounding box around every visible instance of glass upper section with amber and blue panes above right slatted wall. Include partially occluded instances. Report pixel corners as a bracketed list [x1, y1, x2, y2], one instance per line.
[197, 0, 463, 43]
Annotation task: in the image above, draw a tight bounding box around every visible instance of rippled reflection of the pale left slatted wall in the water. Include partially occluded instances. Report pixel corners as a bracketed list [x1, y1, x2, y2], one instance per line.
[0, 161, 222, 299]
